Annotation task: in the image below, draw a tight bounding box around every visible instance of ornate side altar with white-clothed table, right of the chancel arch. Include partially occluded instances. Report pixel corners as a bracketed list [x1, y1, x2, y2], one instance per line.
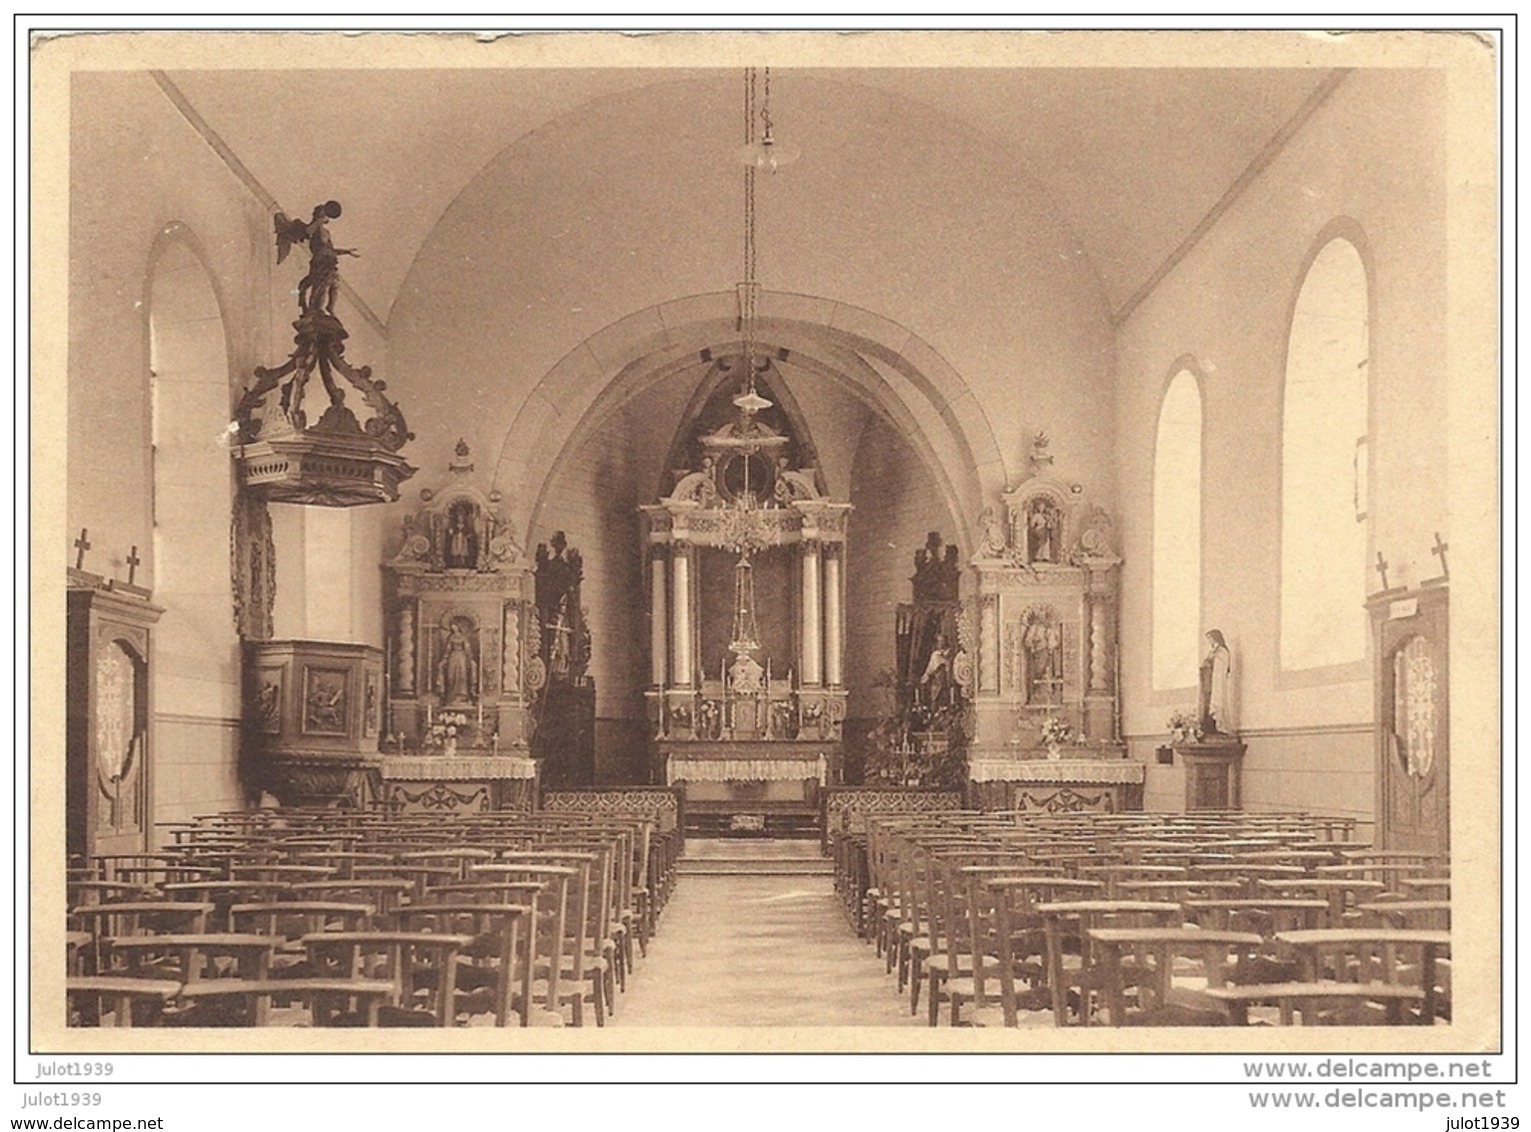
[968, 435, 1145, 812]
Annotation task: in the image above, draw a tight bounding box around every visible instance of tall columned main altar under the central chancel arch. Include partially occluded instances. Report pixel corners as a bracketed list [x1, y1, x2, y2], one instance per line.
[640, 357, 851, 830]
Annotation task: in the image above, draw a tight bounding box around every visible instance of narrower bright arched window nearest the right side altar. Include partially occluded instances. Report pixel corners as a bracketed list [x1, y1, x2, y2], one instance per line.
[1153, 369, 1202, 688]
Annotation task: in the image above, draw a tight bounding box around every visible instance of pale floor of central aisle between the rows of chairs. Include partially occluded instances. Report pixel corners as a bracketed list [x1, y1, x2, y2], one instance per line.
[608, 875, 925, 1026]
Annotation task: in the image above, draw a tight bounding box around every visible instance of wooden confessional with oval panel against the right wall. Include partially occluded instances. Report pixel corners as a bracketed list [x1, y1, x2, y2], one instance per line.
[1369, 585, 1451, 853]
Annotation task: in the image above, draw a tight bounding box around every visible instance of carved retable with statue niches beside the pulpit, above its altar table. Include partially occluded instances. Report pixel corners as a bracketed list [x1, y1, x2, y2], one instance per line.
[380, 441, 535, 754]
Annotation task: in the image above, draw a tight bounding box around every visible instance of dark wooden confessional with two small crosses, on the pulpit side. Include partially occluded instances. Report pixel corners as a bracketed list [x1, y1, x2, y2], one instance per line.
[64, 584, 162, 856]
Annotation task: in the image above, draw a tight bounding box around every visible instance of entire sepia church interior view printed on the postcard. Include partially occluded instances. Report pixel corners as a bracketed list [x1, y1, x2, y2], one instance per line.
[56, 37, 1499, 1032]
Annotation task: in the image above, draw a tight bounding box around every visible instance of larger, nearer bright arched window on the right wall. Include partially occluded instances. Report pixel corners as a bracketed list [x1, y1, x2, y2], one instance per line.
[1281, 237, 1370, 671]
